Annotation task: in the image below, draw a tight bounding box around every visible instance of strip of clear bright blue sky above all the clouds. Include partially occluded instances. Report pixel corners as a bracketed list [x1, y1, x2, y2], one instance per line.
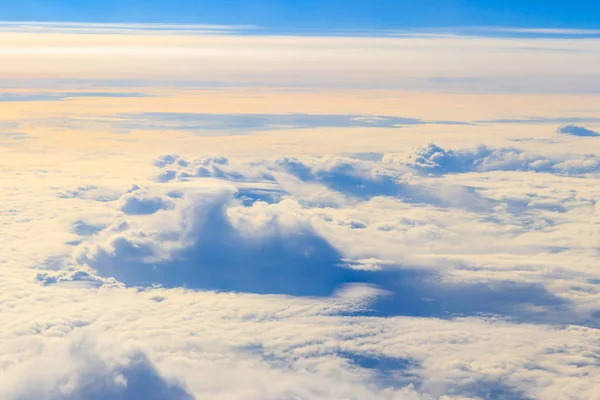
[0, 0, 600, 32]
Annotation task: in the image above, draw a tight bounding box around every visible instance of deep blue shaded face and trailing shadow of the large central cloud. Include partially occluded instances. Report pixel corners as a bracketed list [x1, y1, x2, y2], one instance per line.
[78, 197, 576, 323]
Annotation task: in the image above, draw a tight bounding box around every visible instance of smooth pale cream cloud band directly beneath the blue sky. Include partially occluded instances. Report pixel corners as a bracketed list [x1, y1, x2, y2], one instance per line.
[0, 27, 600, 93]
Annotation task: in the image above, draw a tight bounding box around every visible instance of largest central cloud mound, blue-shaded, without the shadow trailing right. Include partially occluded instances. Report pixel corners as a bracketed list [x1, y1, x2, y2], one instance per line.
[77, 189, 356, 295]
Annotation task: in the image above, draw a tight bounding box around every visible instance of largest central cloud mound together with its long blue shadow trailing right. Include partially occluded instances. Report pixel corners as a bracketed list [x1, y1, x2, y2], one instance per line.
[56, 177, 585, 323]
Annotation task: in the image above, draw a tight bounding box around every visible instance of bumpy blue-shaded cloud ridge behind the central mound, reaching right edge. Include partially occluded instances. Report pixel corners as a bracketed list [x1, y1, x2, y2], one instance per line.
[149, 147, 600, 226]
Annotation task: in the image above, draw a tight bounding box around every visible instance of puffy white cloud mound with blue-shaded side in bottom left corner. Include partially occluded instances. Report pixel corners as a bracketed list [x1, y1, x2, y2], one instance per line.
[0, 338, 194, 400]
